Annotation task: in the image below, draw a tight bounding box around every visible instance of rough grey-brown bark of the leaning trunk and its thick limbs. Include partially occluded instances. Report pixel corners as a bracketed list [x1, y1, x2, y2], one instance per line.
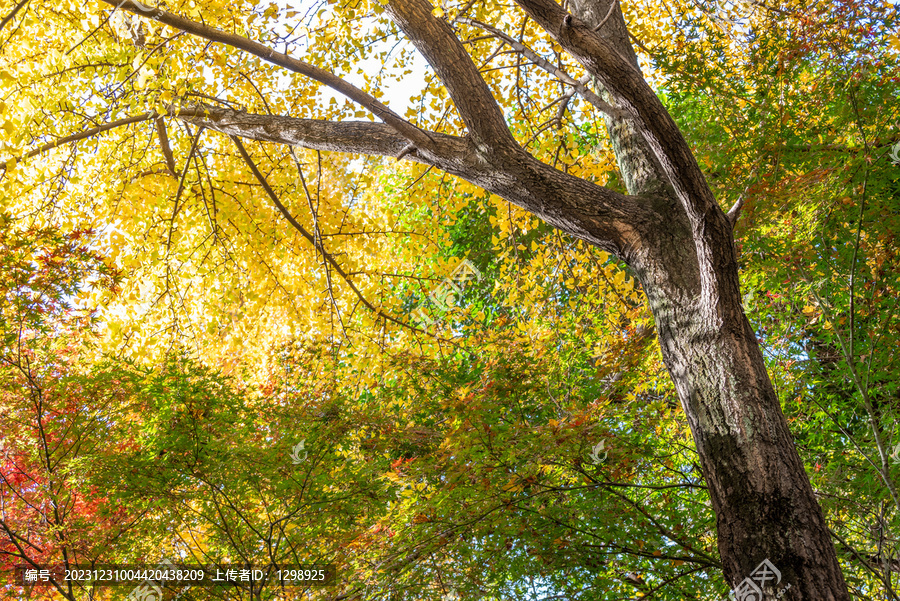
[98, 0, 849, 601]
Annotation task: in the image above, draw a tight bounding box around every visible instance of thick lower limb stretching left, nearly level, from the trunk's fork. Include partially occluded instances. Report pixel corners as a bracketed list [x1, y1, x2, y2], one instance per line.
[176, 107, 656, 261]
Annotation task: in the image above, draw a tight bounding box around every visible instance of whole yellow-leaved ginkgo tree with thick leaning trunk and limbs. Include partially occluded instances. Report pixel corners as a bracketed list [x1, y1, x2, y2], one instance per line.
[0, 0, 896, 599]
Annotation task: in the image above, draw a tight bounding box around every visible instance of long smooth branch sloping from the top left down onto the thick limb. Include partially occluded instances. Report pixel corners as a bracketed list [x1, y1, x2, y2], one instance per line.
[102, 0, 431, 148]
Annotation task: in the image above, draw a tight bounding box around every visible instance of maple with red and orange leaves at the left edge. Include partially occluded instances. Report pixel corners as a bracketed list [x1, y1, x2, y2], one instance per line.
[0, 213, 149, 600]
